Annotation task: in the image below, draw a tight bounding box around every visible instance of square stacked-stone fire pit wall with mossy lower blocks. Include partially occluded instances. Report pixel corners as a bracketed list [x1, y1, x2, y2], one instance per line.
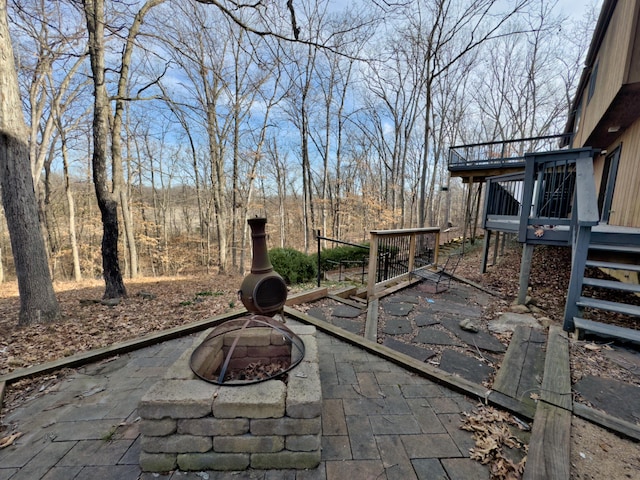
[138, 325, 322, 472]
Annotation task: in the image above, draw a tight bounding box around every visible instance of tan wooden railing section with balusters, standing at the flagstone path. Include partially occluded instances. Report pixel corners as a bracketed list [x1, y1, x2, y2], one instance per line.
[367, 227, 440, 298]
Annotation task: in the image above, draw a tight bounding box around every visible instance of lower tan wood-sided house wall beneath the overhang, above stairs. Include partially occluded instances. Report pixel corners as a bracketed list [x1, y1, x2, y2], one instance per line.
[608, 120, 640, 228]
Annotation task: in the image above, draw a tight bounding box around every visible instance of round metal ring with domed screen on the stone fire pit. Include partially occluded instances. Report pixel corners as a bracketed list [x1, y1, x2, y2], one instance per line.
[189, 315, 305, 386]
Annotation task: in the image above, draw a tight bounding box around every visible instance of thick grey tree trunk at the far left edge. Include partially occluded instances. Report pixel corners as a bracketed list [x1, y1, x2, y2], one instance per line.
[0, 0, 60, 325]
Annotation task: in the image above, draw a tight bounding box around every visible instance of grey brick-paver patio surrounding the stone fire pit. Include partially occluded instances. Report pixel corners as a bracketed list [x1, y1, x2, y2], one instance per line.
[0, 319, 489, 480]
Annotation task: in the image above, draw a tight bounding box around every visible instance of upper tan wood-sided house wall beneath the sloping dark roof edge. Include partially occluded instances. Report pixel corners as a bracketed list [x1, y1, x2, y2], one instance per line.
[574, 0, 640, 146]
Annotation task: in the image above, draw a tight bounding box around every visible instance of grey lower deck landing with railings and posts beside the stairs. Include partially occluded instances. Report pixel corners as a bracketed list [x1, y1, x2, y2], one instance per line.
[482, 148, 599, 331]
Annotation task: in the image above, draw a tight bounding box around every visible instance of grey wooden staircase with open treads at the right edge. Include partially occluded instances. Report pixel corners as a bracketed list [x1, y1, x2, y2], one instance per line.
[573, 239, 640, 343]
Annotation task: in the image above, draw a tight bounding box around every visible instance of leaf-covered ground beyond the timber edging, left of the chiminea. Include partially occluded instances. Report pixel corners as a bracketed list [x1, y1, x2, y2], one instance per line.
[0, 275, 242, 375]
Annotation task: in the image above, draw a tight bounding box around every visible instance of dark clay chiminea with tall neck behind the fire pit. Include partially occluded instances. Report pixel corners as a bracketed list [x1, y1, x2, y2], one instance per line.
[238, 217, 287, 317]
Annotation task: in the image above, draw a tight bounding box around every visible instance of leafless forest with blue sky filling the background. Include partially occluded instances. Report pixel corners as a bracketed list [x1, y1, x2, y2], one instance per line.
[0, 0, 594, 323]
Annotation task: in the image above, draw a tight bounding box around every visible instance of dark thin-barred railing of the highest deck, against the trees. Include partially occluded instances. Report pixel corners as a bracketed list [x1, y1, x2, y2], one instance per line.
[448, 134, 573, 171]
